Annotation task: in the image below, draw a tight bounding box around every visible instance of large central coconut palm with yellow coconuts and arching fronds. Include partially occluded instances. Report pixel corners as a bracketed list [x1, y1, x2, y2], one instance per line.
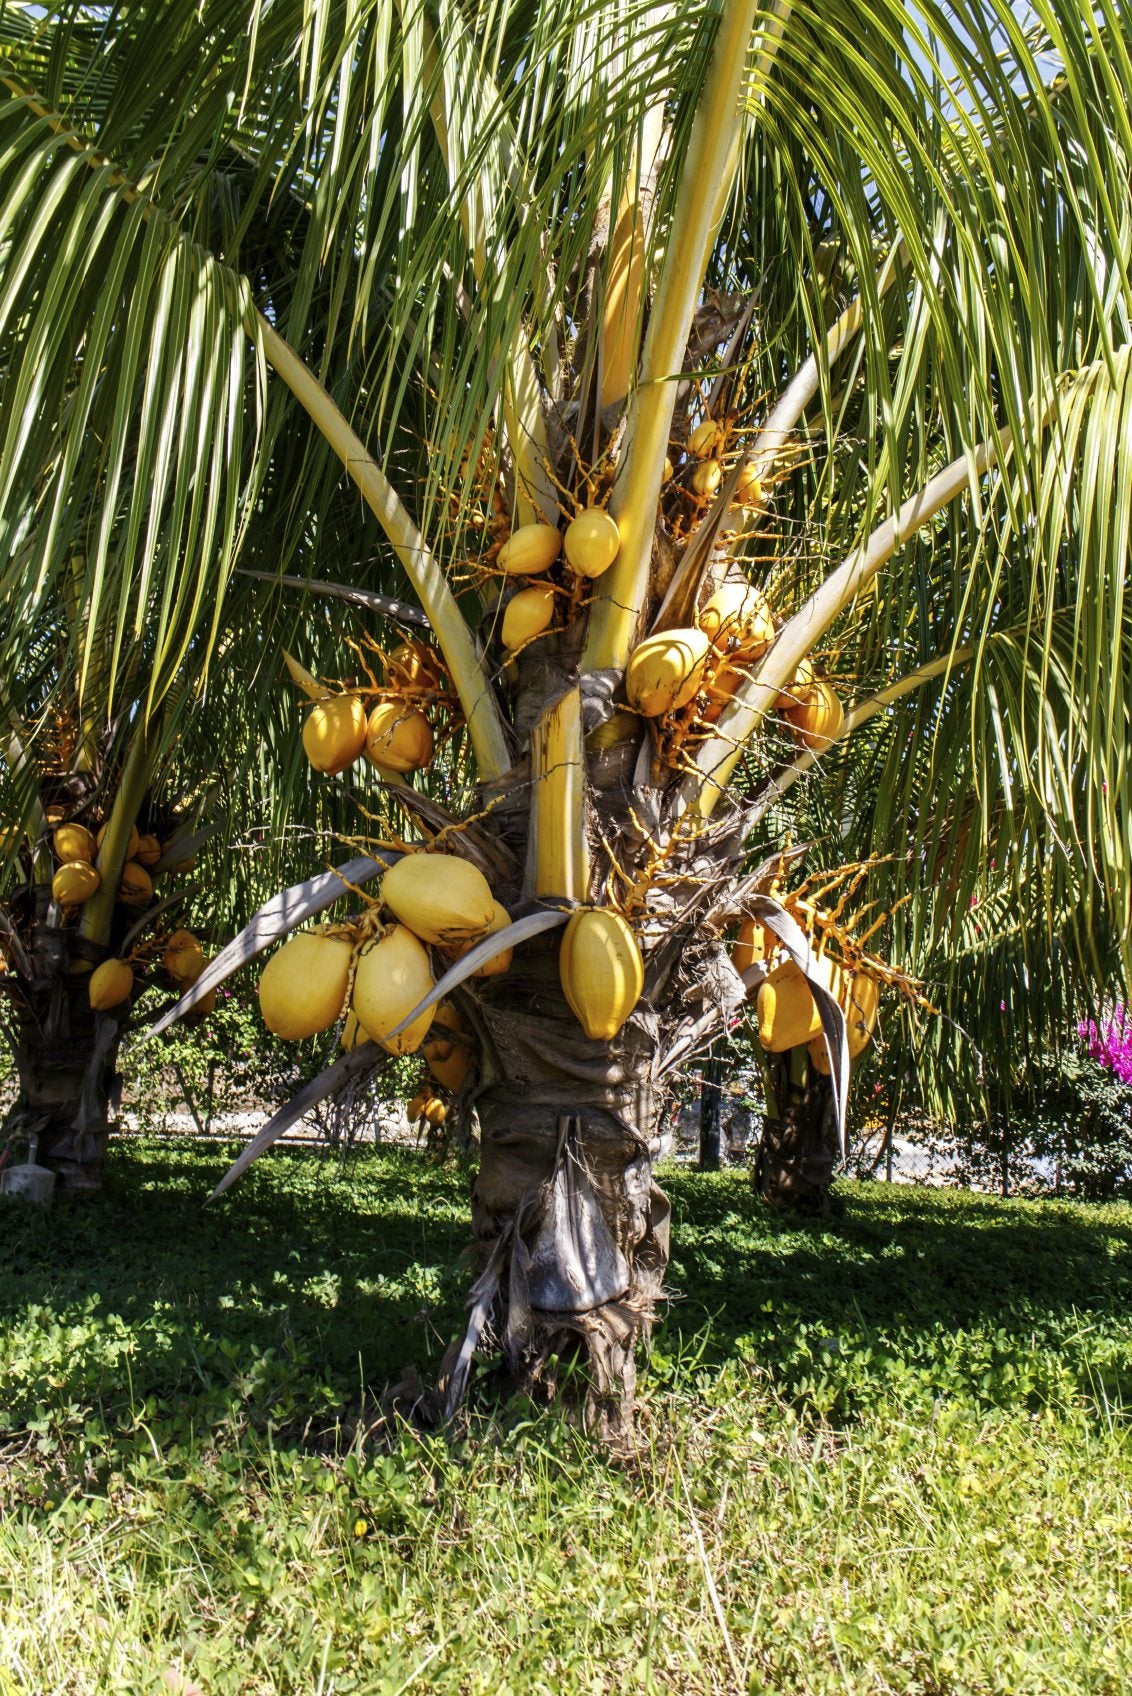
[0, 0, 1132, 1423]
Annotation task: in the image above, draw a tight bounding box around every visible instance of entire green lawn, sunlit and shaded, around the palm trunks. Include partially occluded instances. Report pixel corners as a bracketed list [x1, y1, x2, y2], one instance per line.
[0, 1143, 1132, 1696]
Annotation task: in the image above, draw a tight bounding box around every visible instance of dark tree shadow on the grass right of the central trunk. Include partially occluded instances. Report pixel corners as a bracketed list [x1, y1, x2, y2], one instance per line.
[658, 1169, 1132, 1416]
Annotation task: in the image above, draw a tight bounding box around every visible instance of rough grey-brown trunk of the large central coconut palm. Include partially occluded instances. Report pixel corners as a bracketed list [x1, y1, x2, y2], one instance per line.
[448, 941, 669, 1437]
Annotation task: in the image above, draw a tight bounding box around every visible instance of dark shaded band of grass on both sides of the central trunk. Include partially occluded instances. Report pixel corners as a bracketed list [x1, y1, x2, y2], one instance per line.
[0, 1140, 1132, 1440]
